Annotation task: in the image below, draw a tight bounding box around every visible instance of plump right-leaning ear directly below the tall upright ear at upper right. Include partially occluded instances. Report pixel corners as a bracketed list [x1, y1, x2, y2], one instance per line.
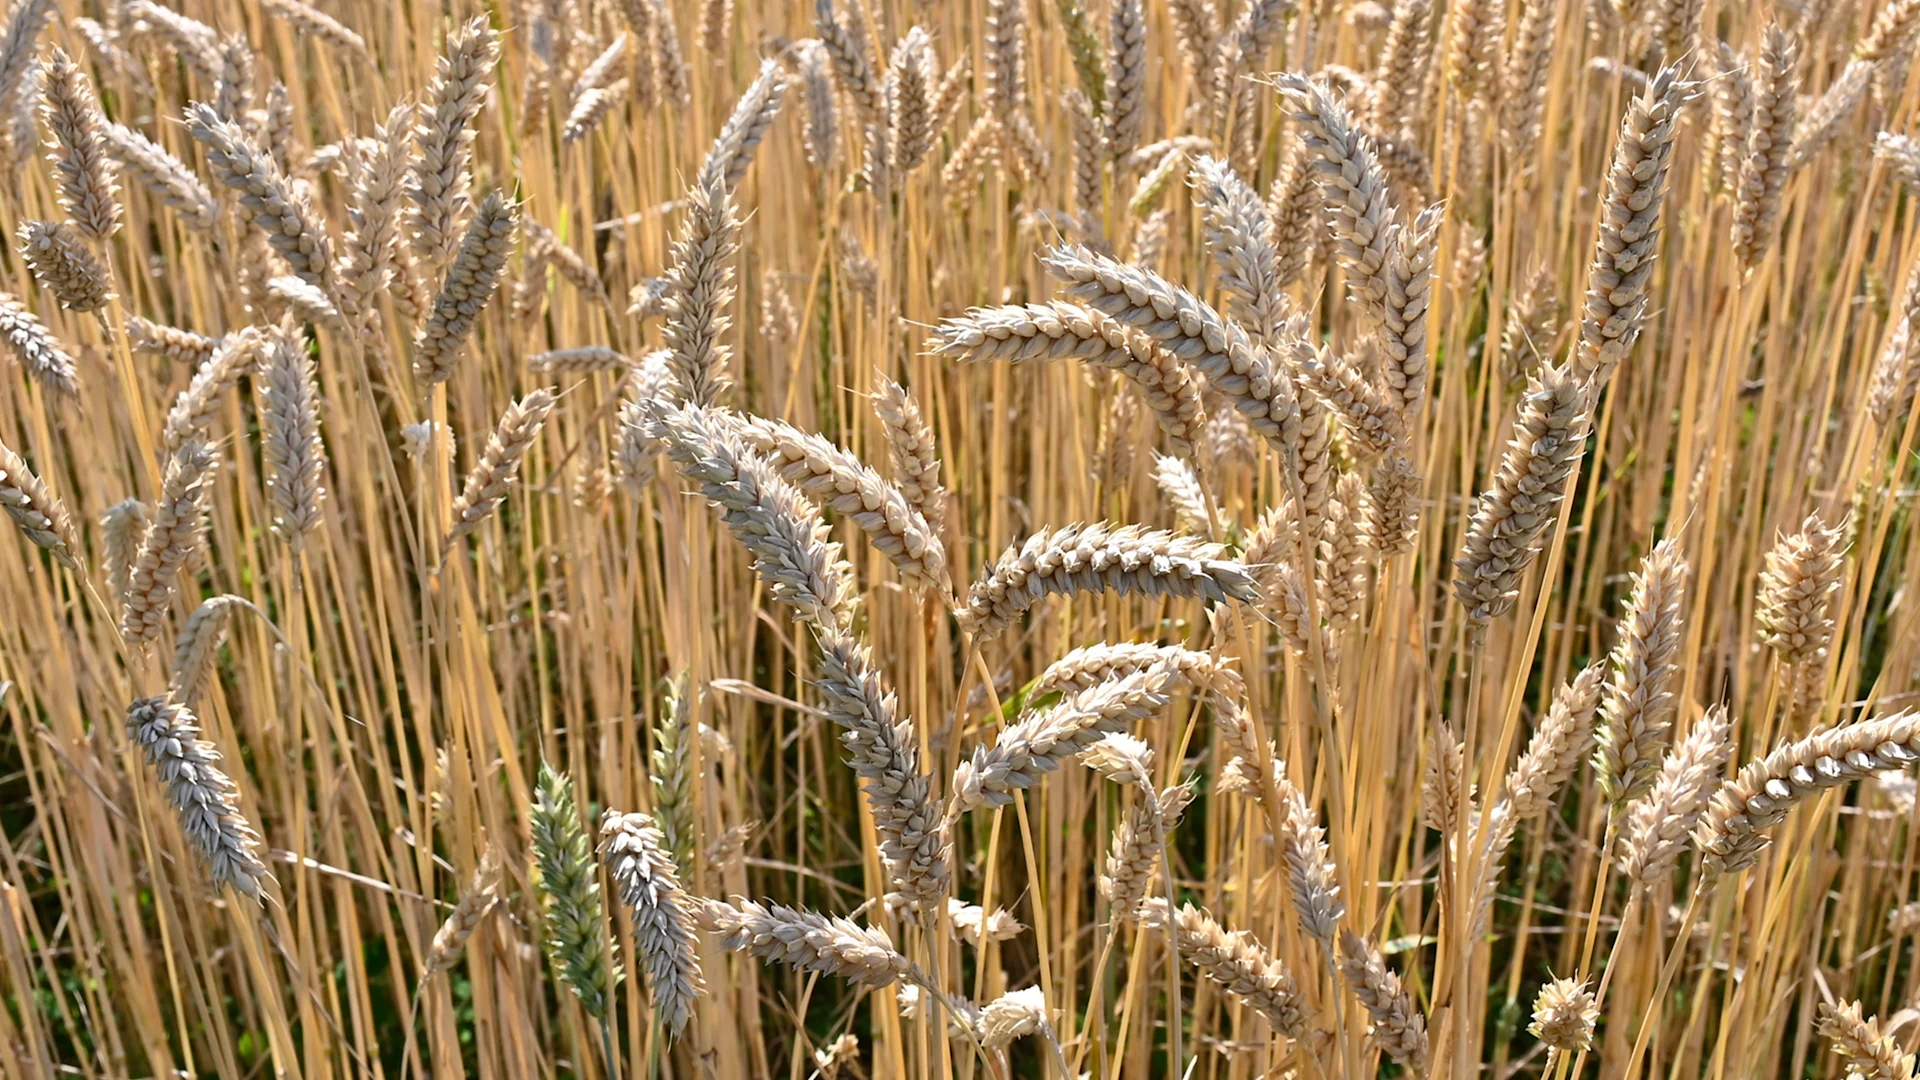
[1453, 365, 1592, 625]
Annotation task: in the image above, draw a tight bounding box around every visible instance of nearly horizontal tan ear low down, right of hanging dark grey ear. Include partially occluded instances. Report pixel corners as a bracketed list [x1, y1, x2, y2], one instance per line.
[695, 899, 912, 990]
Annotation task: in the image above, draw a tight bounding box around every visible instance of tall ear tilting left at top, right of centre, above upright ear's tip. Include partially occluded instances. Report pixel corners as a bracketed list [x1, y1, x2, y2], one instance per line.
[1277, 73, 1394, 325]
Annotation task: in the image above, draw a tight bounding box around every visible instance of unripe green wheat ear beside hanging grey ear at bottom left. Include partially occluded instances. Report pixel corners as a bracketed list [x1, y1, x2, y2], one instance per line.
[532, 761, 622, 1020]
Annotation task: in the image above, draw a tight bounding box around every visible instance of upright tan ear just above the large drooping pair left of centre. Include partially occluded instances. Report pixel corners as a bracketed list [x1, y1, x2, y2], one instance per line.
[662, 179, 739, 405]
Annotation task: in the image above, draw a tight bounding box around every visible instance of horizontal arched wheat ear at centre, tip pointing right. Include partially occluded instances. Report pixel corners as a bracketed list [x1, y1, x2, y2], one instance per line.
[954, 523, 1260, 638]
